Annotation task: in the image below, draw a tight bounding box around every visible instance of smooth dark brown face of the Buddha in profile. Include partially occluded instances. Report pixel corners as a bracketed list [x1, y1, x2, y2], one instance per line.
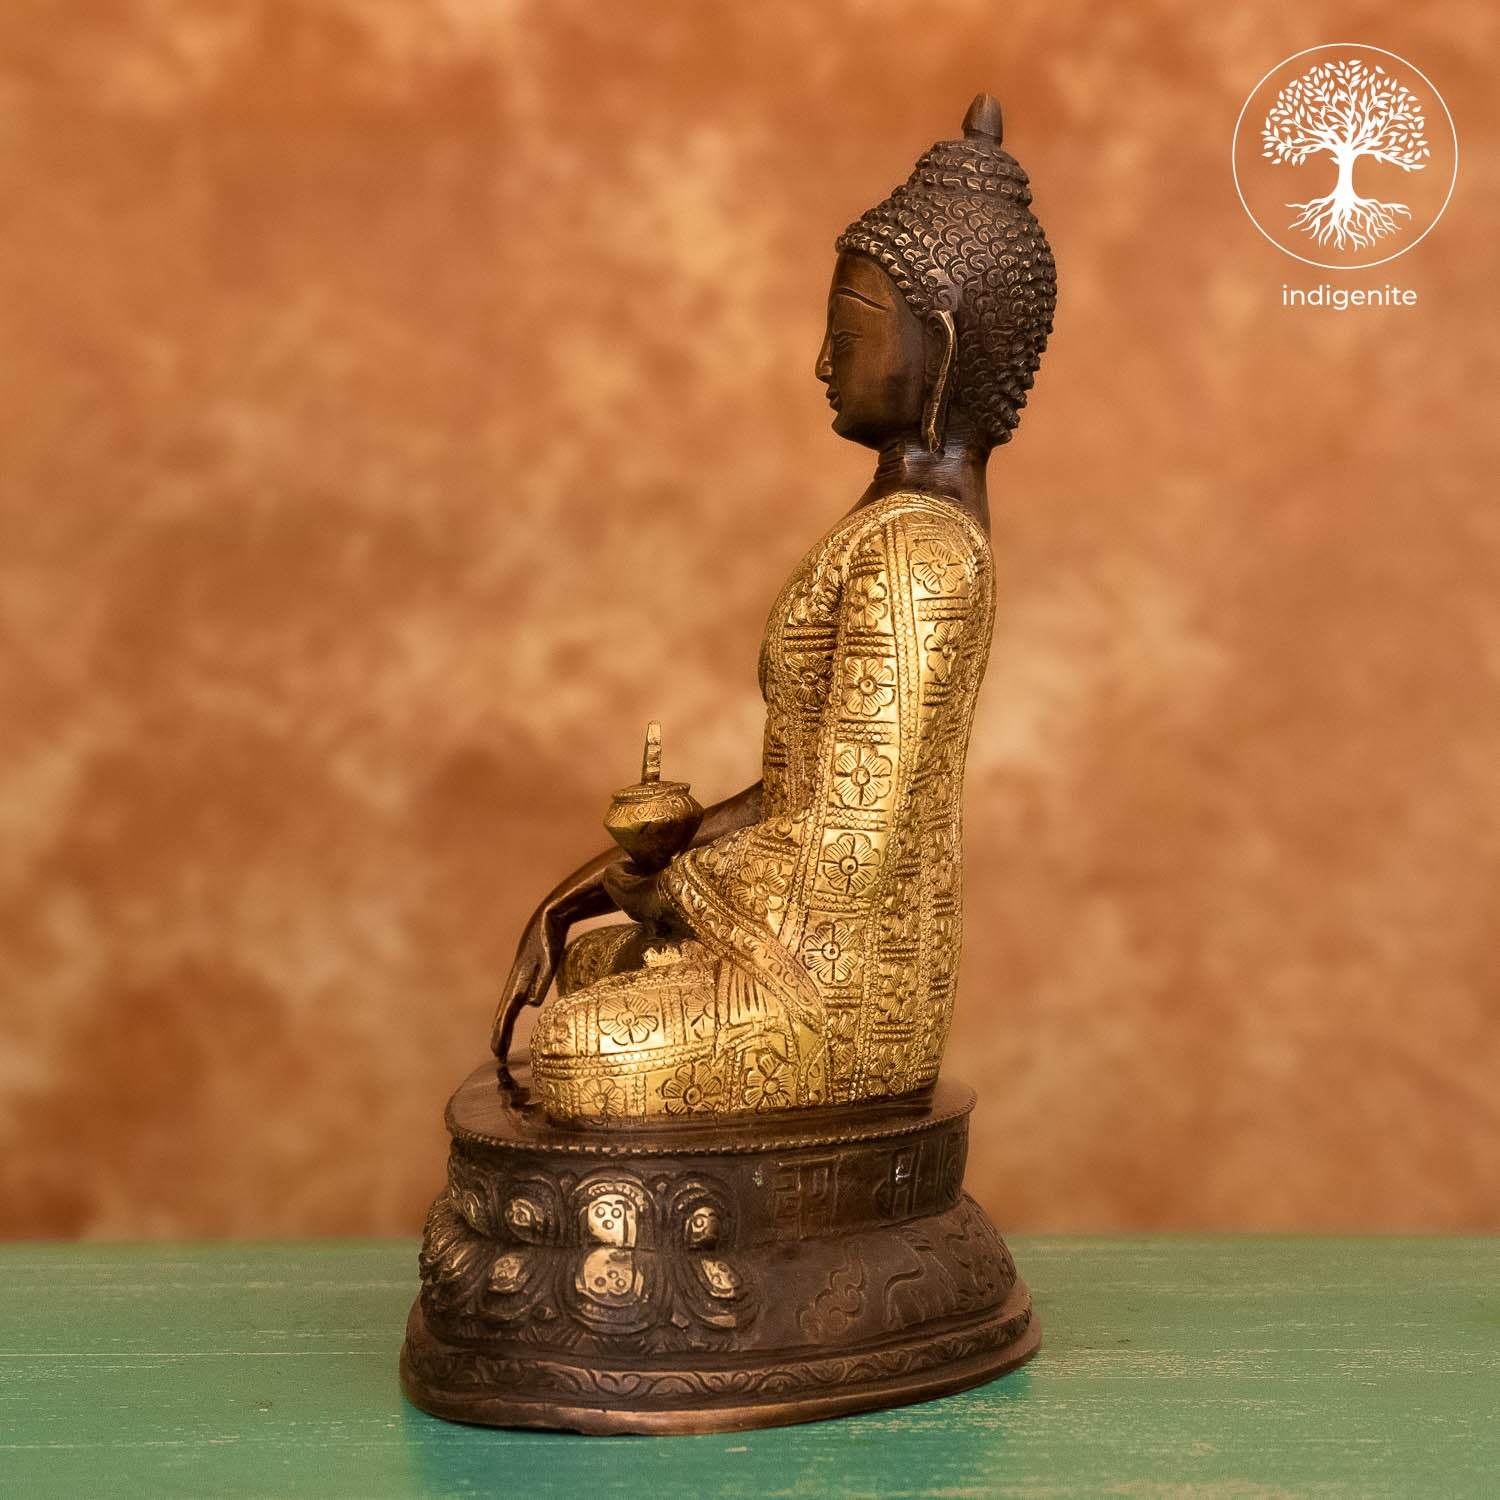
[816, 251, 926, 449]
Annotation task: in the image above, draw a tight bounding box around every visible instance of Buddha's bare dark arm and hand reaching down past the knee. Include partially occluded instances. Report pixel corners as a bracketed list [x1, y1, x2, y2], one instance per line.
[489, 782, 762, 1061]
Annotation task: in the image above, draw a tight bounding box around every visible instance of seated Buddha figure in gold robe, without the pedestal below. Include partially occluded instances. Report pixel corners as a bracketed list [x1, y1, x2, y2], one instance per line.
[492, 95, 1056, 1125]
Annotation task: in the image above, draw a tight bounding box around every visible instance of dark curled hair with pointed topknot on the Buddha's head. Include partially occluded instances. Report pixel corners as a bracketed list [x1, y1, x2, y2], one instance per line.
[836, 95, 1058, 444]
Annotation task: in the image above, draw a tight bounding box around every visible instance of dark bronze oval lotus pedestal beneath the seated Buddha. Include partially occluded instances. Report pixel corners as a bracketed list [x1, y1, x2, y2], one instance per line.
[401, 1062, 1040, 1433]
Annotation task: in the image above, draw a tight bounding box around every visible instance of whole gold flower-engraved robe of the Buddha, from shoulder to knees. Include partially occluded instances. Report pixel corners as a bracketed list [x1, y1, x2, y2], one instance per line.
[533, 494, 995, 1119]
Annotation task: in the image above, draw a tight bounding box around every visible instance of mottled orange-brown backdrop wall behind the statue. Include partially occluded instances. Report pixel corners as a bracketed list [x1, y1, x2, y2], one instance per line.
[0, 0, 1500, 1236]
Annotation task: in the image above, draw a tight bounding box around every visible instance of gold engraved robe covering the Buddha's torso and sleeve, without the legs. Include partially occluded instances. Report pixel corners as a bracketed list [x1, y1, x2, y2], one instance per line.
[671, 495, 995, 1100]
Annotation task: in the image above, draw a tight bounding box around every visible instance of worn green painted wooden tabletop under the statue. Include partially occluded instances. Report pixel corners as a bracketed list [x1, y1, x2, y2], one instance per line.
[0, 1235, 1500, 1500]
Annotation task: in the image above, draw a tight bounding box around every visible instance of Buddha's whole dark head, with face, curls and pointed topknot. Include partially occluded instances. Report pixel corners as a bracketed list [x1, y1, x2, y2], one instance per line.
[818, 95, 1058, 452]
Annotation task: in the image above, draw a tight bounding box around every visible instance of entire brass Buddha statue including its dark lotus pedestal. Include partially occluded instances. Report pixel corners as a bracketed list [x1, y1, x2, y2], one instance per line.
[401, 95, 1056, 1433]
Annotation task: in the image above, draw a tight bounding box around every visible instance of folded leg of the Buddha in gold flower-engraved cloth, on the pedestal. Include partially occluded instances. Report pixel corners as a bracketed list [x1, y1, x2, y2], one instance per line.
[531, 942, 828, 1124]
